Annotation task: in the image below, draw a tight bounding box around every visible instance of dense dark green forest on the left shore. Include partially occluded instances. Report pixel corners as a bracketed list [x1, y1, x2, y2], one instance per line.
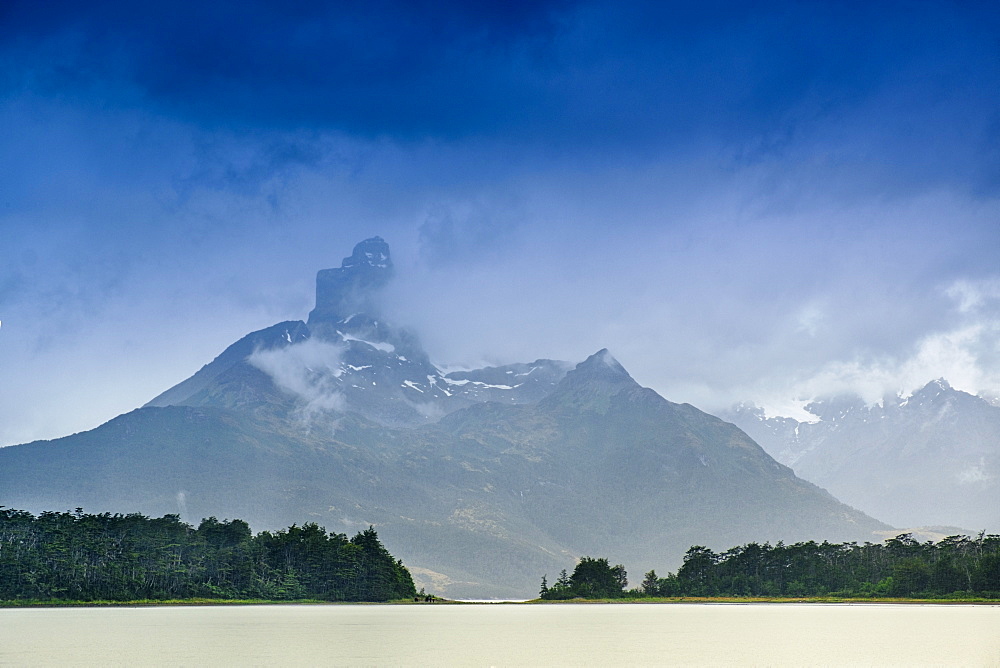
[0, 506, 416, 601]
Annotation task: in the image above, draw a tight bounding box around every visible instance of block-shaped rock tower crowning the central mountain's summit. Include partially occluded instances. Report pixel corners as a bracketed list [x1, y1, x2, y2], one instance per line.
[309, 237, 393, 325]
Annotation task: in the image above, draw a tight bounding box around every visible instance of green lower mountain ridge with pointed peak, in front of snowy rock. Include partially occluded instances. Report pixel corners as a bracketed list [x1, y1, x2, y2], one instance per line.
[0, 351, 888, 596]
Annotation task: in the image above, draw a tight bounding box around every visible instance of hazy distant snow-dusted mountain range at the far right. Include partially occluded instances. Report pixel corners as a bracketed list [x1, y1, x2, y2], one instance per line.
[723, 379, 1000, 532]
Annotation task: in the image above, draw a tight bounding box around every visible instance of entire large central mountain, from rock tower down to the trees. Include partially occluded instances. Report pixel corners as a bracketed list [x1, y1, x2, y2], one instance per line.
[0, 237, 890, 597]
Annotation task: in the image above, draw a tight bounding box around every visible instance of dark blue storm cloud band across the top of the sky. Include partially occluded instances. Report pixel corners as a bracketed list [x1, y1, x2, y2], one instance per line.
[0, 1, 1000, 177]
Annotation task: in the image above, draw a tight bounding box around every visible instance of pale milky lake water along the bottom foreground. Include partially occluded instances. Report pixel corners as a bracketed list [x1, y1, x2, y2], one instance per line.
[0, 604, 1000, 666]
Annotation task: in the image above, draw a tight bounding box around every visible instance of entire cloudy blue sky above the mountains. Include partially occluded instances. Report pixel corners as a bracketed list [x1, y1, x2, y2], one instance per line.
[0, 0, 1000, 444]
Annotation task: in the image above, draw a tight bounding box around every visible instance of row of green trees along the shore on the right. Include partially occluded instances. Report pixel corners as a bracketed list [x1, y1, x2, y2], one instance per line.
[539, 533, 1000, 600]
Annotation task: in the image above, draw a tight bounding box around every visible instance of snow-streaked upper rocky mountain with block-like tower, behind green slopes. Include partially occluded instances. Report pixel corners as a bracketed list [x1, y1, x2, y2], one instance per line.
[147, 237, 572, 426]
